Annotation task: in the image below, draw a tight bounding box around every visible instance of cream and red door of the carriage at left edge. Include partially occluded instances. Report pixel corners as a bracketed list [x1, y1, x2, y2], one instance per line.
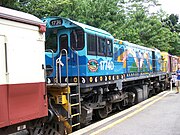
[0, 35, 9, 128]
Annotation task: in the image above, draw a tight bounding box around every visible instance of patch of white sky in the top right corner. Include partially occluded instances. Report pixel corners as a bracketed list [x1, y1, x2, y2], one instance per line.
[158, 0, 180, 17]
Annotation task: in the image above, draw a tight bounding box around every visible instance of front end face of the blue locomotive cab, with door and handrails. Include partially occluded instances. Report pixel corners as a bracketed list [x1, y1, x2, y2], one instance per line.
[44, 18, 84, 83]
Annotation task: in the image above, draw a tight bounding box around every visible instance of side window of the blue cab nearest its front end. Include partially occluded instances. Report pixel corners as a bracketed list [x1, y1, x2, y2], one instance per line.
[87, 34, 97, 55]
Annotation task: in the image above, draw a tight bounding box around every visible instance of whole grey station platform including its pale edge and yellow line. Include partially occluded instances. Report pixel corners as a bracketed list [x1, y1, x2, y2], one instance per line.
[71, 88, 180, 135]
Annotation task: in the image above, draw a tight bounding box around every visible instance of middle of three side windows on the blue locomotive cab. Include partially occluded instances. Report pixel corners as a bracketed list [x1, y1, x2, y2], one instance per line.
[97, 37, 106, 56]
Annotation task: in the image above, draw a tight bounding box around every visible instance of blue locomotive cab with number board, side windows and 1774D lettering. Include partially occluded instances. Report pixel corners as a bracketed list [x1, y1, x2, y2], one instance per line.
[43, 17, 114, 88]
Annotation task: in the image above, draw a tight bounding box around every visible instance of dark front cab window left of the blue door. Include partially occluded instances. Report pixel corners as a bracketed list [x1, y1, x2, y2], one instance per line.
[45, 34, 58, 52]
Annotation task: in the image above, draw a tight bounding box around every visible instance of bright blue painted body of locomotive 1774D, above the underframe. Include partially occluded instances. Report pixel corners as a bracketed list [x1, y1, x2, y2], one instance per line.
[46, 17, 161, 88]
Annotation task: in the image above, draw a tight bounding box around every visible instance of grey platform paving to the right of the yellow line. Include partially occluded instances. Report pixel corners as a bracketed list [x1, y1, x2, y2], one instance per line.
[98, 91, 180, 135]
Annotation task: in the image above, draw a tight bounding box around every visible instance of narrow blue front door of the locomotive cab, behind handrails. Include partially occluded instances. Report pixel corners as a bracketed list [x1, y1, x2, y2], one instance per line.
[59, 30, 71, 80]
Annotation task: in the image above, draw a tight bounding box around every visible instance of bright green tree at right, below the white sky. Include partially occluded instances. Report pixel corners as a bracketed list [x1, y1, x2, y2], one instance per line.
[115, 0, 179, 55]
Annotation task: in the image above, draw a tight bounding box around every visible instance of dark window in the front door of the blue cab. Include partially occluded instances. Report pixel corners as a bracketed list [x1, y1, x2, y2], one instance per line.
[59, 34, 68, 51]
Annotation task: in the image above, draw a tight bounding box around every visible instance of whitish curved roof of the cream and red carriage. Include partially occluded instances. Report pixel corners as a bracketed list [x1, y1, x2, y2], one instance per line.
[0, 6, 42, 25]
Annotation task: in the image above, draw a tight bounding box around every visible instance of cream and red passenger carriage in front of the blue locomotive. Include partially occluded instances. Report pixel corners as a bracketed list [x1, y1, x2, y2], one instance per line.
[0, 7, 48, 135]
